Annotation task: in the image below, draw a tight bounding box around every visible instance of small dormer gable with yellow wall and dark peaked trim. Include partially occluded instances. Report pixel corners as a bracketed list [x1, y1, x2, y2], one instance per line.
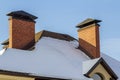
[84, 58, 118, 80]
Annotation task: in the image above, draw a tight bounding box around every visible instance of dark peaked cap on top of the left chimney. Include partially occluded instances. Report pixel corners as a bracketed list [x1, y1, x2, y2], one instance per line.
[7, 10, 37, 20]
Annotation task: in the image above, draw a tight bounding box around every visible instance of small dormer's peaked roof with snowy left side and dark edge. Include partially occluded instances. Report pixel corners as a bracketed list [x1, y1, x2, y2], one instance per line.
[83, 58, 118, 79]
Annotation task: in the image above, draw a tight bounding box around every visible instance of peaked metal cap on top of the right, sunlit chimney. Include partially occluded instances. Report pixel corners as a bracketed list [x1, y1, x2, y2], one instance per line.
[76, 18, 101, 28]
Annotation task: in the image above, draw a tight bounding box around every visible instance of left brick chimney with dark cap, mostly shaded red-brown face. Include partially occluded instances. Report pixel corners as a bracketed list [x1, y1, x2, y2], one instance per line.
[7, 11, 37, 49]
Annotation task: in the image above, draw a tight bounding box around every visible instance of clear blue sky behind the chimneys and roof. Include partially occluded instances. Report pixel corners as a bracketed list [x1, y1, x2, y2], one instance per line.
[0, 0, 120, 61]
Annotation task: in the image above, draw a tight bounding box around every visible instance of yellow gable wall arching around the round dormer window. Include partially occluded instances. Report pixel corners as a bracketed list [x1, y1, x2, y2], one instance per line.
[89, 64, 111, 80]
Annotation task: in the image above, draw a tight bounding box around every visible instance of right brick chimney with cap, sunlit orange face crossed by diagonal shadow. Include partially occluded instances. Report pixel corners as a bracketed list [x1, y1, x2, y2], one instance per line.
[77, 18, 101, 59]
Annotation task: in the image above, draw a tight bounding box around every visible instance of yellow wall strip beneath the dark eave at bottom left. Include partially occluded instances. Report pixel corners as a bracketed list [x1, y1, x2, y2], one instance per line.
[0, 74, 35, 80]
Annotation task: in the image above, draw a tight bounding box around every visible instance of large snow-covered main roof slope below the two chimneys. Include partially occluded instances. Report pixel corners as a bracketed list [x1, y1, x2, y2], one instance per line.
[0, 37, 120, 80]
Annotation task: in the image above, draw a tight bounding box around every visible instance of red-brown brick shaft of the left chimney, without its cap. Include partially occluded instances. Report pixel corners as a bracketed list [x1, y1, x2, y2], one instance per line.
[9, 17, 35, 49]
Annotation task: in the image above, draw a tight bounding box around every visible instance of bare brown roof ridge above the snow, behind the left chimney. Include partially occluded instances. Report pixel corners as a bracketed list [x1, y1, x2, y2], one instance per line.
[1, 30, 76, 48]
